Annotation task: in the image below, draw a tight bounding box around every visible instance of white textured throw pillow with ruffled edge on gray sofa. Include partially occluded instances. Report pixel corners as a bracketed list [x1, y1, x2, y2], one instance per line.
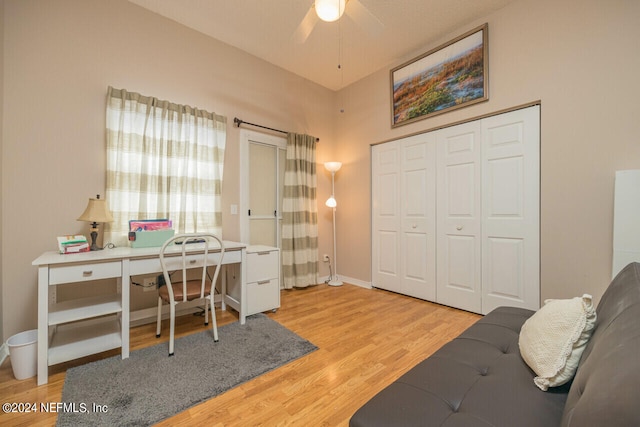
[518, 294, 596, 391]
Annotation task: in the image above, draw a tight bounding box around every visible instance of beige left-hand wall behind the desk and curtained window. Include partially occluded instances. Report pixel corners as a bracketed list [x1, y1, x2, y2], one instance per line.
[1, 0, 335, 339]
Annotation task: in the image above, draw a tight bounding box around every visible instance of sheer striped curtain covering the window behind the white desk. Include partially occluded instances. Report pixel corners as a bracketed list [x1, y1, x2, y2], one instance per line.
[104, 87, 226, 246]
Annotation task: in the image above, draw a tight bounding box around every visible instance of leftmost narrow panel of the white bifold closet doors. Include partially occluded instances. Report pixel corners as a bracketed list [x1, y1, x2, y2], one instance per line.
[371, 141, 402, 292]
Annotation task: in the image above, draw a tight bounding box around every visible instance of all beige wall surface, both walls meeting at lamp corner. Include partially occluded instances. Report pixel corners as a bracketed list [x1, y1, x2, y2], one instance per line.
[0, 0, 640, 339]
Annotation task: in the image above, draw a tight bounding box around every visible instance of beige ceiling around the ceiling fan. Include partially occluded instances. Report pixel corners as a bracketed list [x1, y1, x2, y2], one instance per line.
[129, 0, 515, 90]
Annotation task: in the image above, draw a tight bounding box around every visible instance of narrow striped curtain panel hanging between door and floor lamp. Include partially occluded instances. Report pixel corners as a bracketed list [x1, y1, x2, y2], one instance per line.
[282, 133, 318, 289]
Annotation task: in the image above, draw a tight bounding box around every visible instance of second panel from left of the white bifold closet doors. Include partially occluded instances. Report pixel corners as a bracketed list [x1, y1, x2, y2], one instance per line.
[399, 134, 436, 301]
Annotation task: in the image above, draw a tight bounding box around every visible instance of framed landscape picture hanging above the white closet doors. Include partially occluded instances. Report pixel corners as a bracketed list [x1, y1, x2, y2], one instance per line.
[391, 24, 489, 127]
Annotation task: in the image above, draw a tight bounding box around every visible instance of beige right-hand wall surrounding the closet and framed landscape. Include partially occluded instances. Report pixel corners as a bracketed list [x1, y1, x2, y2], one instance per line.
[336, 0, 640, 299]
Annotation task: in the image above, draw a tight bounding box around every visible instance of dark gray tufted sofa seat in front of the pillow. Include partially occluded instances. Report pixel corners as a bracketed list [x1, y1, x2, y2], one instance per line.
[349, 307, 568, 427]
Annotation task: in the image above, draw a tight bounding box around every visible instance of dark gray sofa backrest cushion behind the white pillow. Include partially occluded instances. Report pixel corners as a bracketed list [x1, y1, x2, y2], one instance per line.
[562, 263, 640, 427]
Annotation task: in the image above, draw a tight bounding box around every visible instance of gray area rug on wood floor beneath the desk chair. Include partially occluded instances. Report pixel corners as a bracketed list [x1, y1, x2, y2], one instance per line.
[57, 314, 317, 427]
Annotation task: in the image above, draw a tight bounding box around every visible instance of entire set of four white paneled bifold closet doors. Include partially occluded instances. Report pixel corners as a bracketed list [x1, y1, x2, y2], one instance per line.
[372, 106, 540, 313]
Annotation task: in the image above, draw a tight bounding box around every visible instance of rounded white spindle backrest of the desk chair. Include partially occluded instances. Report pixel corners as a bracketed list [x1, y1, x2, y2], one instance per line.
[160, 233, 224, 302]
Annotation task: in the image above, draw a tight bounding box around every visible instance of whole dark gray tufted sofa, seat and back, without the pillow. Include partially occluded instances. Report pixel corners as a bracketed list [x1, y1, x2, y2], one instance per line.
[349, 263, 640, 427]
